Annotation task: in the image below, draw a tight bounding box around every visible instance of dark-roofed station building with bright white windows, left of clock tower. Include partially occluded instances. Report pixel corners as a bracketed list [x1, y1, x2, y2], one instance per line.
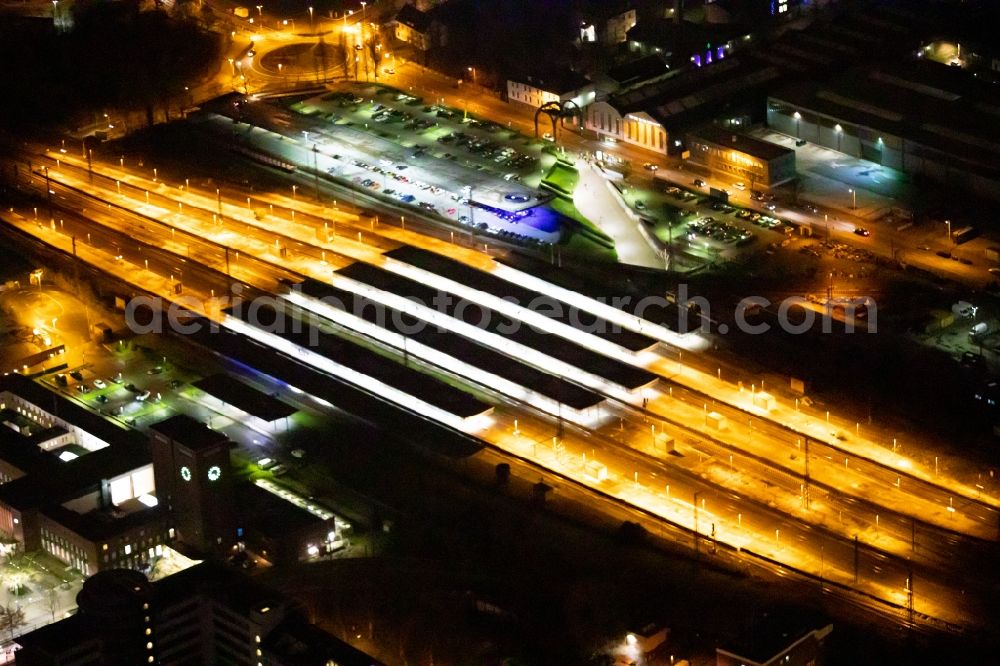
[0, 375, 167, 575]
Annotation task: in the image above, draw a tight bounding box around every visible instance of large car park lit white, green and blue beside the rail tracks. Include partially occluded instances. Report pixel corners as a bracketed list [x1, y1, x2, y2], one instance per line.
[280, 84, 561, 243]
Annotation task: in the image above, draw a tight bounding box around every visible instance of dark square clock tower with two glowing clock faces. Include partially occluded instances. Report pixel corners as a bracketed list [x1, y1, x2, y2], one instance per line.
[150, 414, 236, 552]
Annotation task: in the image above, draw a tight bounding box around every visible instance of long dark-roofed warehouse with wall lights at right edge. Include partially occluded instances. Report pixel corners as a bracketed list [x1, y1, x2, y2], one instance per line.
[767, 56, 1000, 199]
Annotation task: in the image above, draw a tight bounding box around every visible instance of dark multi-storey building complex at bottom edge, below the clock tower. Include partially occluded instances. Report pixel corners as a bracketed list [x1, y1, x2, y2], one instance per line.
[17, 563, 380, 666]
